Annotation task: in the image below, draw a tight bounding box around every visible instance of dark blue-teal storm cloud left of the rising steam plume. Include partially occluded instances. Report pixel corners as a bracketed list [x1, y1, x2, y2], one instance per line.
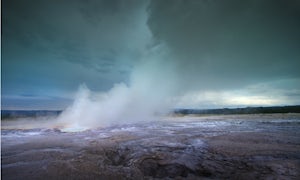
[2, 0, 149, 98]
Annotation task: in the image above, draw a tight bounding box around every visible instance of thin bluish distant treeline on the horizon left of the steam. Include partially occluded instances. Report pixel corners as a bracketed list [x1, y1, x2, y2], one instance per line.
[1, 110, 62, 119]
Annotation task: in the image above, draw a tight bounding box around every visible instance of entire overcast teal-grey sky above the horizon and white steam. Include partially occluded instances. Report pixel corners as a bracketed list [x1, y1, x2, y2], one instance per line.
[1, 0, 300, 109]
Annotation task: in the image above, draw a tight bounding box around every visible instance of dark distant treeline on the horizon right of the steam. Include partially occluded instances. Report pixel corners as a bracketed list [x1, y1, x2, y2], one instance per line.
[174, 105, 300, 115]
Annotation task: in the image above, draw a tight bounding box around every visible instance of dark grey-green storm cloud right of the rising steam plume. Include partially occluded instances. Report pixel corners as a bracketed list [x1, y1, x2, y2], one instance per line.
[148, 0, 300, 89]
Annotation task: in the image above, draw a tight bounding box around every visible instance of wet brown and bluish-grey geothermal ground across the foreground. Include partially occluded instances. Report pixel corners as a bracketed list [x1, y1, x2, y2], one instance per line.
[1, 113, 300, 180]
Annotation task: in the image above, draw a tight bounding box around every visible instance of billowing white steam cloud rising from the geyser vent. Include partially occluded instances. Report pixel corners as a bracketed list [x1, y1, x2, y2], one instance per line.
[58, 45, 176, 131]
